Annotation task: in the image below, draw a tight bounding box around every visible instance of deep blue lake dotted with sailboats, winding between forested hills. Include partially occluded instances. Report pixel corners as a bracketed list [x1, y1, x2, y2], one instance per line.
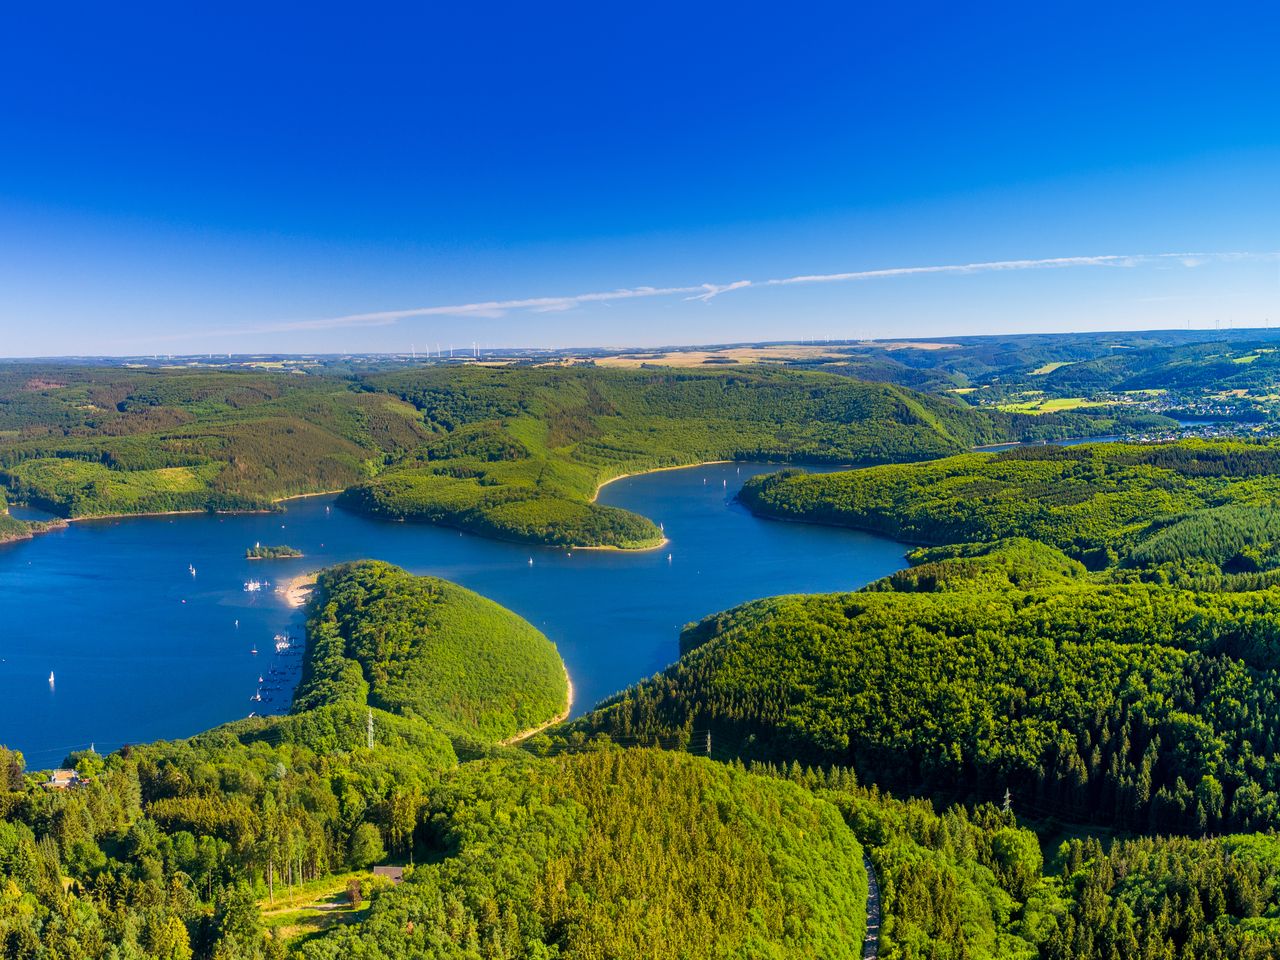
[0, 463, 905, 768]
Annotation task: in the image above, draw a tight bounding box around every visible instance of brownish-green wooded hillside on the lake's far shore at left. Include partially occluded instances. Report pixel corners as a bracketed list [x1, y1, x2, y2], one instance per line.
[0, 365, 429, 517]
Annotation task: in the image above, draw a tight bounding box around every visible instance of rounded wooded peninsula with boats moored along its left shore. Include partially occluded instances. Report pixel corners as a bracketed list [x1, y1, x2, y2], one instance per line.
[293, 561, 568, 742]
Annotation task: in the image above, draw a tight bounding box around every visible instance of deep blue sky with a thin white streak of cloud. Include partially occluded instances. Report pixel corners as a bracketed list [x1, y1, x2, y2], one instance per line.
[0, 3, 1280, 356]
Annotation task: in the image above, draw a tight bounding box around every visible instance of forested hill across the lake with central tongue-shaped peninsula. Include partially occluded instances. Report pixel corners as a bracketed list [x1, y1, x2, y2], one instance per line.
[343, 367, 995, 548]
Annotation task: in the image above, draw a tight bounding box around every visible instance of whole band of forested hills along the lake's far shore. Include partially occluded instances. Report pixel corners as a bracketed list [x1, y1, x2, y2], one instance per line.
[0, 365, 1018, 547]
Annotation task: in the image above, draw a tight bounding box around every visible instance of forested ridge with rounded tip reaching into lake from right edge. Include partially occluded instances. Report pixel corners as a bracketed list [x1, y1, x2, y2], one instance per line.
[740, 440, 1280, 586]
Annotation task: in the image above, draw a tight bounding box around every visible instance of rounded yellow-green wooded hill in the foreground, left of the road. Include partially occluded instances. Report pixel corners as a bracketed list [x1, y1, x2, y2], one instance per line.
[301, 750, 867, 960]
